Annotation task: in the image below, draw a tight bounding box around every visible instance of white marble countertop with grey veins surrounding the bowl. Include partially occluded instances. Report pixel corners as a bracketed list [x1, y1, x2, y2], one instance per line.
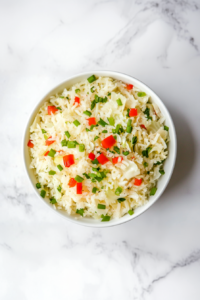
[0, 0, 200, 300]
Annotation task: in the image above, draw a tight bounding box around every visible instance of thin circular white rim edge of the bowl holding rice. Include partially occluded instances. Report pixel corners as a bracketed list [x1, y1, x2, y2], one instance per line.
[22, 70, 177, 228]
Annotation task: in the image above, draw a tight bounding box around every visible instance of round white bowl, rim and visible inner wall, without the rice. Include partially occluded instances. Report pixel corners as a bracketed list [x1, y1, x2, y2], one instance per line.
[23, 71, 177, 227]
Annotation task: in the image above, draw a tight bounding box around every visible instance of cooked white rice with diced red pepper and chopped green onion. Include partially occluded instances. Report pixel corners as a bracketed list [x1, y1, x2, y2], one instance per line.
[27, 75, 169, 221]
